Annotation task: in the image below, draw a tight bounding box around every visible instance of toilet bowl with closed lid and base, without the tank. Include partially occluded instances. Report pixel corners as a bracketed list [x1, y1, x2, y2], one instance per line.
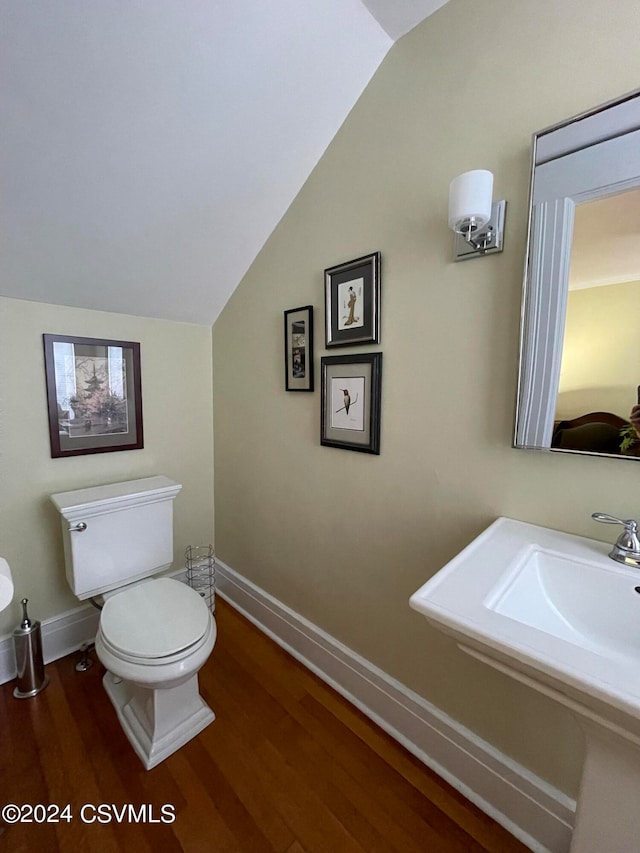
[96, 578, 216, 770]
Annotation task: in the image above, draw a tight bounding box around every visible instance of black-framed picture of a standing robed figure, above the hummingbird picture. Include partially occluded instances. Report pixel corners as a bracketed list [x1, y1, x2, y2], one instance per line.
[324, 252, 380, 347]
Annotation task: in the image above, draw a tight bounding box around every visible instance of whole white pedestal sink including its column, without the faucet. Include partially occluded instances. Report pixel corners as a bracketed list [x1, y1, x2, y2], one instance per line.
[410, 518, 640, 853]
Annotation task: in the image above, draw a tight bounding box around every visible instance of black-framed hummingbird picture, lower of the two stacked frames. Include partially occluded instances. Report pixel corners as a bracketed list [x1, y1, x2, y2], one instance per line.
[320, 352, 382, 454]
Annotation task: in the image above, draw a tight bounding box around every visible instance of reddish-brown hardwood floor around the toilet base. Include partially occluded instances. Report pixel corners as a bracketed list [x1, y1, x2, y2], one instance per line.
[0, 600, 526, 853]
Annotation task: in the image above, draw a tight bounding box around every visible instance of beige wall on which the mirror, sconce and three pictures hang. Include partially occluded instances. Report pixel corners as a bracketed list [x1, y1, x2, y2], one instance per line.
[213, 0, 640, 794]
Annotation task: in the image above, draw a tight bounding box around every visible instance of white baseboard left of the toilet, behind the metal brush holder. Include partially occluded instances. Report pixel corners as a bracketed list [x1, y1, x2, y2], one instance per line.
[0, 605, 100, 684]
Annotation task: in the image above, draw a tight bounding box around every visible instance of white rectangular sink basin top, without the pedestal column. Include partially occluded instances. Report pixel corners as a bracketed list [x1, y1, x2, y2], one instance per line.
[410, 518, 640, 724]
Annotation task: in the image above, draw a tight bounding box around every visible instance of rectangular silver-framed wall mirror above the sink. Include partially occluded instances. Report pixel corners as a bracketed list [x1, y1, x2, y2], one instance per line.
[514, 91, 640, 459]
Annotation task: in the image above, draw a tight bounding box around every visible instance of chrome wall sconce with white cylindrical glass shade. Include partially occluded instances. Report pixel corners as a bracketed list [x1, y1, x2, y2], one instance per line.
[449, 169, 507, 261]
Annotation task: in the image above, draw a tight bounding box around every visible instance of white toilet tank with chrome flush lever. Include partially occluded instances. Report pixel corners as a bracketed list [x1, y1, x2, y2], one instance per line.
[51, 477, 182, 599]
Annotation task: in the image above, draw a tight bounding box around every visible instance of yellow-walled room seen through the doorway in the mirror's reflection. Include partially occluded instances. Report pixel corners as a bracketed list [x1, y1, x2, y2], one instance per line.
[551, 189, 640, 456]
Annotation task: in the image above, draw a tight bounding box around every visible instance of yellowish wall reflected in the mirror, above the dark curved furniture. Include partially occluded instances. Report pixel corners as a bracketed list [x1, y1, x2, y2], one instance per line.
[556, 281, 640, 420]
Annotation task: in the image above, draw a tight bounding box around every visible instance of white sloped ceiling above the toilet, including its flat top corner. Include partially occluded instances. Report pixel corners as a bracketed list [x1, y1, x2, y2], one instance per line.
[0, 0, 446, 324]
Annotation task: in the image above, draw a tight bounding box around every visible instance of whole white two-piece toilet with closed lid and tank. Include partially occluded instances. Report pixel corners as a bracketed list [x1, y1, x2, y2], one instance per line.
[51, 476, 216, 770]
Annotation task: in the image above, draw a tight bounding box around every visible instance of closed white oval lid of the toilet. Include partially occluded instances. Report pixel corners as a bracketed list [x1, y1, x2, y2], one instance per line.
[100, 578, 211, 658]
